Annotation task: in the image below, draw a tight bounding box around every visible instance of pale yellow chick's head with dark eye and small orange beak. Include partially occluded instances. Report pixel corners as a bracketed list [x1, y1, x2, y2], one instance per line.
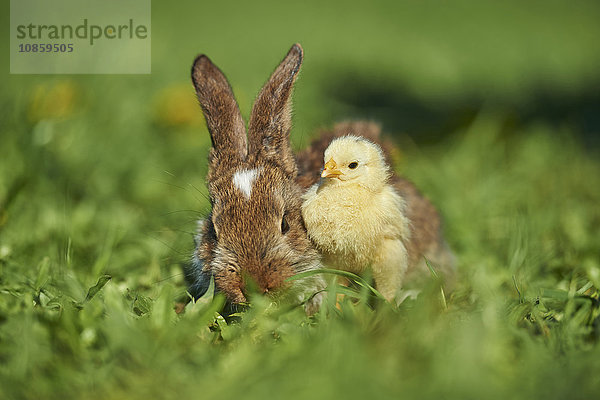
[321, 135, 389, 190]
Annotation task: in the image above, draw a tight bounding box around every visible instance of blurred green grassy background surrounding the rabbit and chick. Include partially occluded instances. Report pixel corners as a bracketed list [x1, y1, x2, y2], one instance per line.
[0, 1, 600, 399]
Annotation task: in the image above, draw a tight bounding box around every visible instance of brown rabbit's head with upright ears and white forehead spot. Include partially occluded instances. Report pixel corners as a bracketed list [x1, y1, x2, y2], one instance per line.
[190, 44, 322, 312]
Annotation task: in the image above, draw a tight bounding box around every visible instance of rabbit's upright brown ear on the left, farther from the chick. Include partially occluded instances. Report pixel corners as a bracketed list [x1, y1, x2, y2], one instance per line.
[192, 55, 248, 169]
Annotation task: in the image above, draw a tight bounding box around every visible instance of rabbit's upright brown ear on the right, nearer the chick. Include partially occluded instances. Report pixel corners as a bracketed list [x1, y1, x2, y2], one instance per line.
[248, 44, 302, 176]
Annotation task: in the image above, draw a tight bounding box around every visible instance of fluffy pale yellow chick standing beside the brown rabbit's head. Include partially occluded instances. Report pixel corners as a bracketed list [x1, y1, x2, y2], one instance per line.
[302, 135, 411, 301]
